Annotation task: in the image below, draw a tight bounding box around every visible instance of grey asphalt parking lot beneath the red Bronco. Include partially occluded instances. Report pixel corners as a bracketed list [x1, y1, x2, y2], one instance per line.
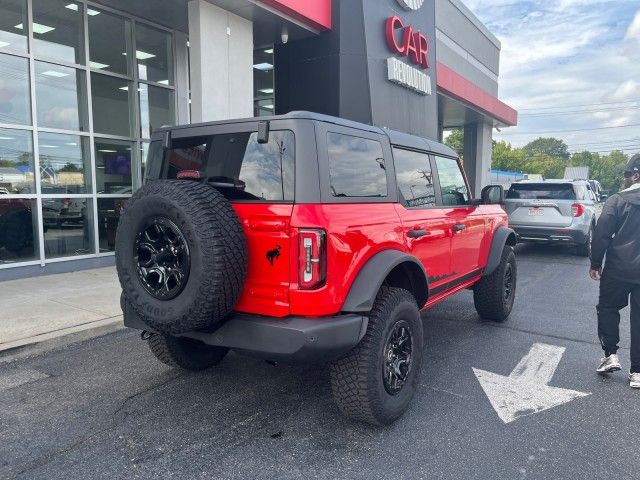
[0, 246, 640, 479]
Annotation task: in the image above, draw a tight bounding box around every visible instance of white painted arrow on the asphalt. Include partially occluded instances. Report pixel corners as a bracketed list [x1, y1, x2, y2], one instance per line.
[473, 343, 590, 423]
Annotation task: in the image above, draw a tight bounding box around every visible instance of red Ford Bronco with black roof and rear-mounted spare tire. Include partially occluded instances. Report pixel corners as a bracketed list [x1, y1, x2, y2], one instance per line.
[116, 112, 516, 425]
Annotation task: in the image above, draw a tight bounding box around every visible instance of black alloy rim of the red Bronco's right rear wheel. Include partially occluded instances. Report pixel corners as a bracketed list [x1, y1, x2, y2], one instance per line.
[382, 320, 413, 395]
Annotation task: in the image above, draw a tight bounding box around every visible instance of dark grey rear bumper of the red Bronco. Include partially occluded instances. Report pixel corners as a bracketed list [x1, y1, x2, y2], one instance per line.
[124, 308, 368, 363]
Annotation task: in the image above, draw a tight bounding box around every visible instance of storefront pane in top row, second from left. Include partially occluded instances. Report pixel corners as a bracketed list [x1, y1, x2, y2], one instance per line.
[33, 0, 85, 64]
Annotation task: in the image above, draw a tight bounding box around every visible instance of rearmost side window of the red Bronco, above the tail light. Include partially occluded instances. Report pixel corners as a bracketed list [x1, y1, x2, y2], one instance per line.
[327, 133, 387, 197]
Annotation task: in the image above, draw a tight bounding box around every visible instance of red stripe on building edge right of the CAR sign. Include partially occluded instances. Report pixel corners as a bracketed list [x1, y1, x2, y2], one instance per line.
[436, 62, 518, 127]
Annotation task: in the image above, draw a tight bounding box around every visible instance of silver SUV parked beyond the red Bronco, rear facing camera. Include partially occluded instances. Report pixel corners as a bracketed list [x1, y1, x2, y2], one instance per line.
[505, 180, 597, 257]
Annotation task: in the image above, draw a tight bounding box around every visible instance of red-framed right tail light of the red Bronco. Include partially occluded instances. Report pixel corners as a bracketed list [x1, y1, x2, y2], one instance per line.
[298, 229, 327, 290]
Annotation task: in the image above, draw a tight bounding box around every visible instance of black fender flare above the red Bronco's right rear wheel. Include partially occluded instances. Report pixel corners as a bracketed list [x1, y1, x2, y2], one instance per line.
[341, 250, 429, 313]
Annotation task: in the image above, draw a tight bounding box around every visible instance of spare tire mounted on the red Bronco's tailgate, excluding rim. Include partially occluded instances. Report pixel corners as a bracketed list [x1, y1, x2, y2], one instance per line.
[116, 180, 248, 334]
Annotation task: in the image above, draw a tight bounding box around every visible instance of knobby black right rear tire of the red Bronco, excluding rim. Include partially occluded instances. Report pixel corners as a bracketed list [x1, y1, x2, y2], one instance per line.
[330, 287, 424, 425]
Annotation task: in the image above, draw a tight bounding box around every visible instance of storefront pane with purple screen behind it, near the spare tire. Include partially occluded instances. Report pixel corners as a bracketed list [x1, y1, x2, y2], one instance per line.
[95, 139, 135, 194]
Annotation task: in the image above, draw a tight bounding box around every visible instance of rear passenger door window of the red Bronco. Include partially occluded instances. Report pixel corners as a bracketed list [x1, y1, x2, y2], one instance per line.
[393, 148, 436, 207]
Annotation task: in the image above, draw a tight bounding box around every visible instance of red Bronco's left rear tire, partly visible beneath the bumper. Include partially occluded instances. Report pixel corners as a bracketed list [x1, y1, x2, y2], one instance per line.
[147, 333, 229, 372]
